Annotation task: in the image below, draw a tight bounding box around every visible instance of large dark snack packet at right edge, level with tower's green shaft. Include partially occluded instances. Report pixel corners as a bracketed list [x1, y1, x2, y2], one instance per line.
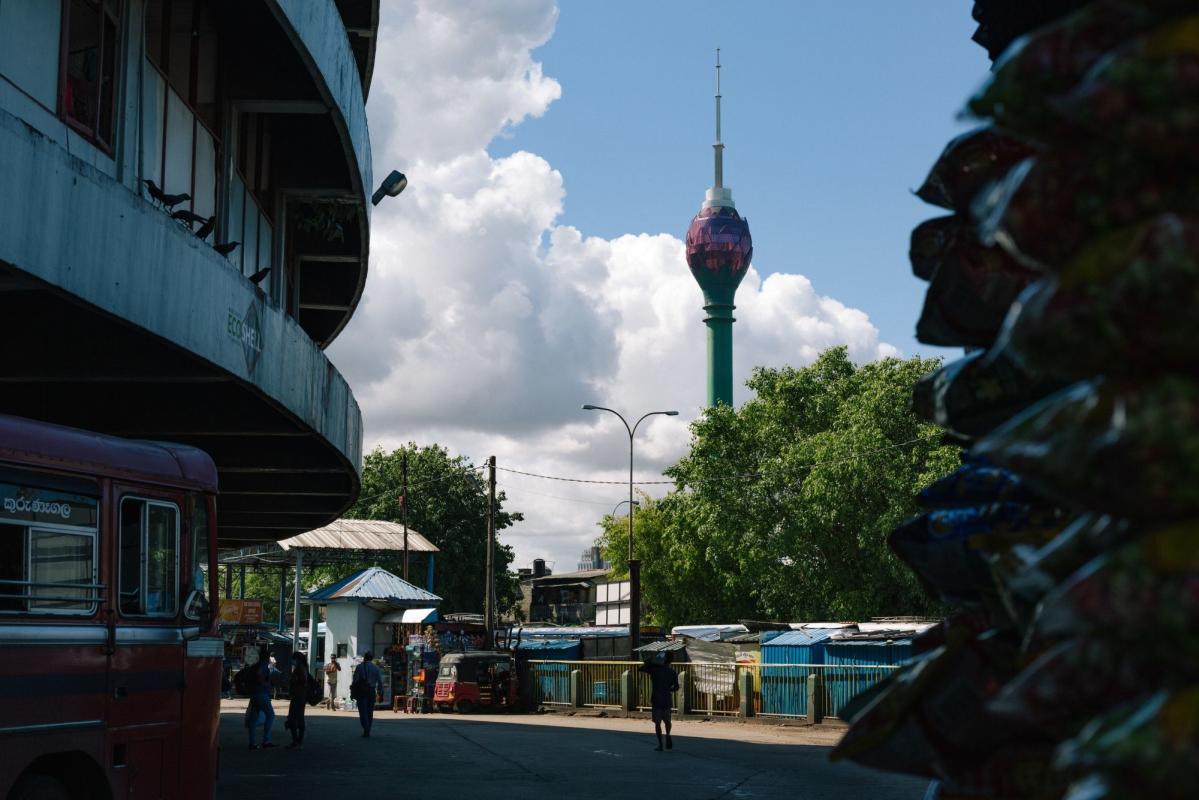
[996, 215, 1199, 379]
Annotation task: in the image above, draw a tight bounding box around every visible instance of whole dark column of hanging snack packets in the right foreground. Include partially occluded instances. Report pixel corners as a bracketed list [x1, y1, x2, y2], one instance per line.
[833, 0, 1199, 800]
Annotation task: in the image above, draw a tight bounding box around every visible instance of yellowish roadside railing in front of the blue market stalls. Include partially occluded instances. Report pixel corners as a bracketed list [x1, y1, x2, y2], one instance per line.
[528, 661, 898, 721]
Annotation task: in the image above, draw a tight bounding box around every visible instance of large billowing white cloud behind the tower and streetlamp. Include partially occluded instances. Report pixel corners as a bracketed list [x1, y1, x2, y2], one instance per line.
[330, 0, 897, 571]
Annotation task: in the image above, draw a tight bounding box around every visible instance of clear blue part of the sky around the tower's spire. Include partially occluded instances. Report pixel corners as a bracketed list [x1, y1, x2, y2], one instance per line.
[489, 0, 989, 355]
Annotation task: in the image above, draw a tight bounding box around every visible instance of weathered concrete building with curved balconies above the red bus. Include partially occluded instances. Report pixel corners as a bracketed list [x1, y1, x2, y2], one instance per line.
[0, 0, 379, 545]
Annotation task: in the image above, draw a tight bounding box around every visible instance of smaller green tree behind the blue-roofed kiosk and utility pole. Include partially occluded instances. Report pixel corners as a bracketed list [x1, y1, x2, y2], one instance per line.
[299, 444, 524, 612]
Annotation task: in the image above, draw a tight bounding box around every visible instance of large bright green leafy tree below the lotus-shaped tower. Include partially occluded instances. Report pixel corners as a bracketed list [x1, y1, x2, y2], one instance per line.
[601, 348, 959, 625]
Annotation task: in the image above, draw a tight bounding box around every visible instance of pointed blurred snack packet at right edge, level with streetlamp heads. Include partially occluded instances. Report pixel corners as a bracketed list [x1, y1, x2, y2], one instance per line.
[974, 375, 1199, 521]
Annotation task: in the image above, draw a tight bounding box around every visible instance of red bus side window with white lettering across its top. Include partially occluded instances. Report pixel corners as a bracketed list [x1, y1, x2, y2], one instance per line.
[0, 483, 100, 614]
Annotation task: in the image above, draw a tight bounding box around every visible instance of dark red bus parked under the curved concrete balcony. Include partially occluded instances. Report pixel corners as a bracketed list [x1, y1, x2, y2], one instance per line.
[0, 415, 224, 800]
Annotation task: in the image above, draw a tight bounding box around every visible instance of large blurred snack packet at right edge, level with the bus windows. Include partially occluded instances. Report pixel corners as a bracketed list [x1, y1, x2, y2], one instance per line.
[1034, 522, 1199, 647]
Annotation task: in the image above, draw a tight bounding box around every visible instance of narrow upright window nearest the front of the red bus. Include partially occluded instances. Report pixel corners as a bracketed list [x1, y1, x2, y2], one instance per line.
[120, 498, 179, 616]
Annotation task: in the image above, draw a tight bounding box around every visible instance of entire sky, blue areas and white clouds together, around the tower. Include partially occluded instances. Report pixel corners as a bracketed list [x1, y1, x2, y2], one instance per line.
[330, 0, 989, 570]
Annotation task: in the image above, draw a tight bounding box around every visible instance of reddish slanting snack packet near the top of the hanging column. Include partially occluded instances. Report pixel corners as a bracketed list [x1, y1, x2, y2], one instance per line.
[968, 0, 1173, 134]
